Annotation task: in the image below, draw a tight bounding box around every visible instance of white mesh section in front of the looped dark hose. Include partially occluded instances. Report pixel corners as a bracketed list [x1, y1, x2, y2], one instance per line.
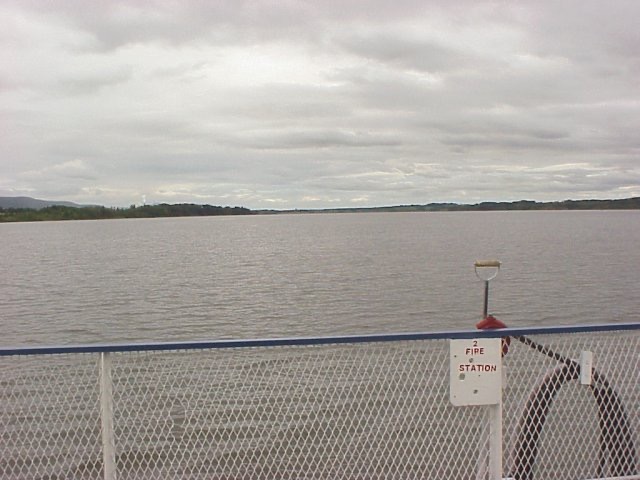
[504, 331, 640, 479]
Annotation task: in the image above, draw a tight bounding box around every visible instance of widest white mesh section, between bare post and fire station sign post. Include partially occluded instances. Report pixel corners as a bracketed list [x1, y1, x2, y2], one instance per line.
[113, 341, 490, 479]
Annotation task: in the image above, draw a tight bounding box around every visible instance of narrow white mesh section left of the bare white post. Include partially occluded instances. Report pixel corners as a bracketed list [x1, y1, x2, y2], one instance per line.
[0, 354, 102, 479]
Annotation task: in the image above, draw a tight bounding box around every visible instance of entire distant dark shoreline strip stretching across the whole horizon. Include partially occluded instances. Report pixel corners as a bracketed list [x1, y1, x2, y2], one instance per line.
[0, 197, 640, 223]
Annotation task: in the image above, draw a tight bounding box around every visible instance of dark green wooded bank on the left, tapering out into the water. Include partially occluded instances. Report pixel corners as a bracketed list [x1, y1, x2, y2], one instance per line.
[0, 203, 252, 222]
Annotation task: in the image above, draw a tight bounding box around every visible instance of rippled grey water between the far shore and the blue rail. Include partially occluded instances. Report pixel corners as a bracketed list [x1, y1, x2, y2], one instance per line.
[0, 211, 640, 346]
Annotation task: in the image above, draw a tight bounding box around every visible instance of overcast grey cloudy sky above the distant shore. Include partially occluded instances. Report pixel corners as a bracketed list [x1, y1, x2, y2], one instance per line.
[0, 0, 640, 209]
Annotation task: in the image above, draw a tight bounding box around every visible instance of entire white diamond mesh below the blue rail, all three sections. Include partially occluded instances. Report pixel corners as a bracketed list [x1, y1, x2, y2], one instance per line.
[0, 330, 640, 480]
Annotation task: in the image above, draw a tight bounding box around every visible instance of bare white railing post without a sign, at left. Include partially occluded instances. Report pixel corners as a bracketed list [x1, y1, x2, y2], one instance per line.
[100, 352, 116, 480]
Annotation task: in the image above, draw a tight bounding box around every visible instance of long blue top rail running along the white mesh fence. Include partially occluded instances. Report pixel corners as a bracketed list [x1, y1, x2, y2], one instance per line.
[0, 322, 640, 357]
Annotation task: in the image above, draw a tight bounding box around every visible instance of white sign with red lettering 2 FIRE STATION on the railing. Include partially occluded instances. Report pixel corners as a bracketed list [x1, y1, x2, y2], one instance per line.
[449, 338, 502, 406]
